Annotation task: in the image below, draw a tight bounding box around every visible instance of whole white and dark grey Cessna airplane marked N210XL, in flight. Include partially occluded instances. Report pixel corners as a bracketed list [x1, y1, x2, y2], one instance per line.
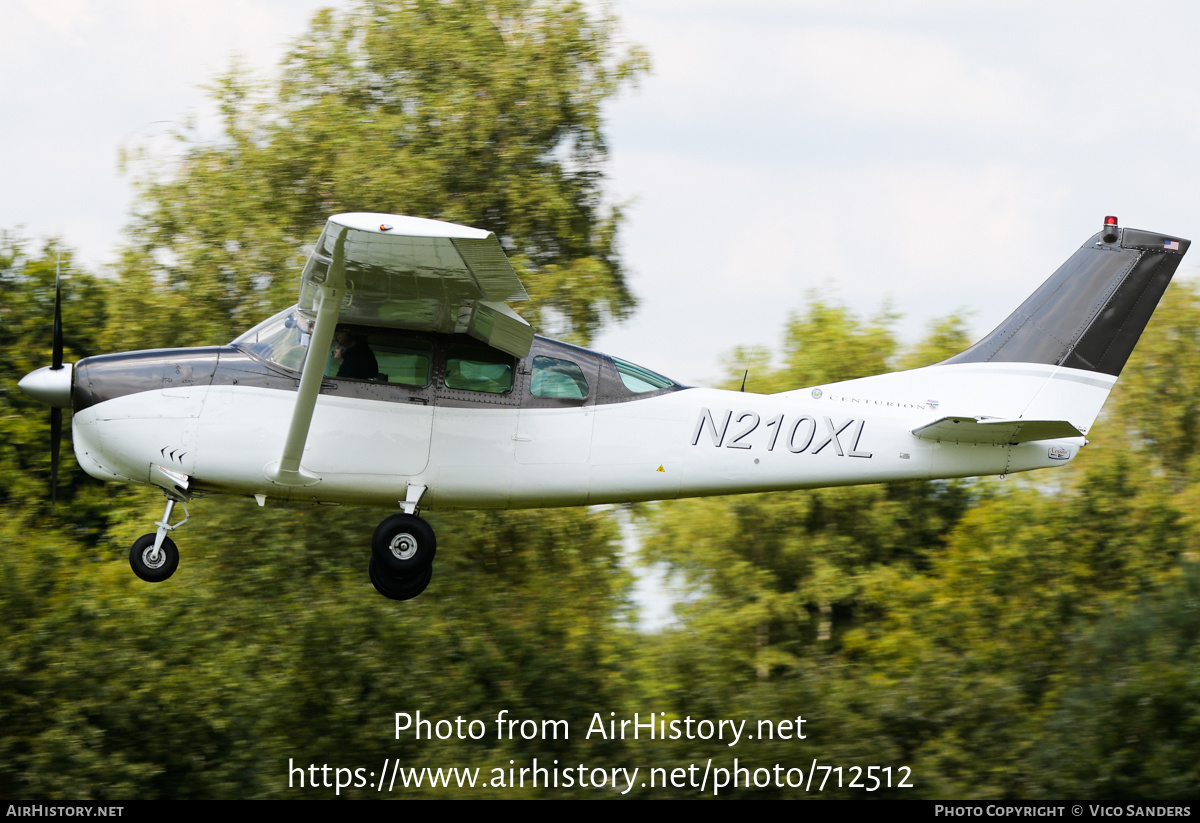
[19, 214, 1190, 600]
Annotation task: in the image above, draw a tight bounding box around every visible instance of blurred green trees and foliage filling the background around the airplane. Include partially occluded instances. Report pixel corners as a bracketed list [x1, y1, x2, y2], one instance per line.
[0, 0, 1200, 801]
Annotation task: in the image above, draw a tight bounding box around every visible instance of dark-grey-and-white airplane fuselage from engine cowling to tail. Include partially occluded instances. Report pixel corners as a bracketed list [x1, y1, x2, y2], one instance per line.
[65, 319, 1112, 507]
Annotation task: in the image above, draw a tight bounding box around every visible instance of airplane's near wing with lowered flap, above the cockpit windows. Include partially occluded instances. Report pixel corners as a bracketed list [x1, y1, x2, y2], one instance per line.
[300, 212, 534, 358]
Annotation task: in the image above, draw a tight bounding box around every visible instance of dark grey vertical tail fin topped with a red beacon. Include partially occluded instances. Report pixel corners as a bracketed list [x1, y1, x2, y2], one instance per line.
[943, 217, 1192, 377]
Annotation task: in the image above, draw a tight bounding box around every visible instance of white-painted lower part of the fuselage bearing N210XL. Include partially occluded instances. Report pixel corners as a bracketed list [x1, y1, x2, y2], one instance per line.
[73, 362, 1115, 507]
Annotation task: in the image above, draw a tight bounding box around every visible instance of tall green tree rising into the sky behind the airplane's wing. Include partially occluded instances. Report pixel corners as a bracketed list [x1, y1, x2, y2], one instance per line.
[124, 0, 647, 344]
